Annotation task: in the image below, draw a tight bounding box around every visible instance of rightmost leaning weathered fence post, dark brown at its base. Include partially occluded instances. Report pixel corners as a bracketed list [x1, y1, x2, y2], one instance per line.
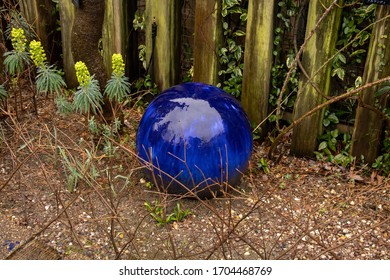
[351, 6, 390, 163]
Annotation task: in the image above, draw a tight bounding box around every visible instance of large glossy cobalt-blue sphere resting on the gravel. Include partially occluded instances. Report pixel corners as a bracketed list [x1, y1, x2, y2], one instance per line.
[136, 83, 252, 198]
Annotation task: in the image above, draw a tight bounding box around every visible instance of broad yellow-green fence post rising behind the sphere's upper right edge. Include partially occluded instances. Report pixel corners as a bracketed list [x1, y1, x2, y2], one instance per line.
[241, 0, 275, 132]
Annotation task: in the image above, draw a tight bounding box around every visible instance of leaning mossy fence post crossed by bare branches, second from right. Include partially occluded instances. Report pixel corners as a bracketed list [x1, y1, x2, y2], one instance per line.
[291, 0, 342, 156]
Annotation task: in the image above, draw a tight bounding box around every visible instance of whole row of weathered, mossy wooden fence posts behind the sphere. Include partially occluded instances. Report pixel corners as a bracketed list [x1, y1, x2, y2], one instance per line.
[16, 0, 390, 162]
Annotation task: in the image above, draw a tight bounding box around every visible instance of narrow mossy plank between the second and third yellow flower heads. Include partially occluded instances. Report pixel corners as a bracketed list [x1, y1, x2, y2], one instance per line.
[59, 0, 78, 88]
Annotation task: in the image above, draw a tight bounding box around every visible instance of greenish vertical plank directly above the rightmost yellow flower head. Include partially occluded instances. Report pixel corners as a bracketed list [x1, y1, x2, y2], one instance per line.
[102, 0, 128, 77]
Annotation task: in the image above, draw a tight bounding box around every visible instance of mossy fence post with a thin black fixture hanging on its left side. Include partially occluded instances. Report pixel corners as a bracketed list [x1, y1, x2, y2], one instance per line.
[145, 0, 182, 91]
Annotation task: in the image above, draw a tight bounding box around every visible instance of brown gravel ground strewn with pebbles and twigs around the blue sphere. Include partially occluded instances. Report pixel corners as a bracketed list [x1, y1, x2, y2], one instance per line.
[0, 101, 390, 260]
